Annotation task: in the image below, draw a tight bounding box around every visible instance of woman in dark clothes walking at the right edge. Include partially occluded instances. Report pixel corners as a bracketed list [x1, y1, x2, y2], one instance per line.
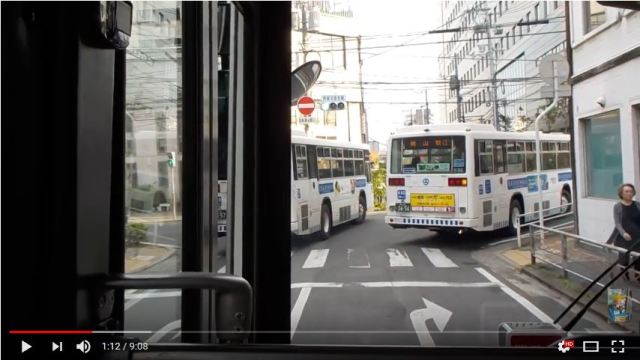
[607, 184, 640, 280]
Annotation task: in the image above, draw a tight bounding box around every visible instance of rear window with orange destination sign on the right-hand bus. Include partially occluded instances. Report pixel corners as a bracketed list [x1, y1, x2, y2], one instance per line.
[391, 136, 466, 174]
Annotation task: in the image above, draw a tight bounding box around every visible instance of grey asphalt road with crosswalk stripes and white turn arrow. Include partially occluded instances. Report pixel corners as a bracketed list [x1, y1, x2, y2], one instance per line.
[125, 214, 610, 346]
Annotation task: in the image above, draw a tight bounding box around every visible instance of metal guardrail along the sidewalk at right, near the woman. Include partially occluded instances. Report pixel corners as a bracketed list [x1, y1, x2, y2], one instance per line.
[517, 205, 640, 304]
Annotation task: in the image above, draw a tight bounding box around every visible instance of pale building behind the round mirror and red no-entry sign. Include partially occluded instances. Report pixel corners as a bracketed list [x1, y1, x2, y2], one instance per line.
[291, 1, 368, 144]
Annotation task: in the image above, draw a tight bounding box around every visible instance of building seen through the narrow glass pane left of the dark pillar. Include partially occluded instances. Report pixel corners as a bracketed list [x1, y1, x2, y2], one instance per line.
[125, 1, 182, 213]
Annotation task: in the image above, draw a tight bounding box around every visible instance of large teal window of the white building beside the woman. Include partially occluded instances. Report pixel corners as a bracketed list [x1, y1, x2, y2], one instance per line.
[582, 110, 622, 200]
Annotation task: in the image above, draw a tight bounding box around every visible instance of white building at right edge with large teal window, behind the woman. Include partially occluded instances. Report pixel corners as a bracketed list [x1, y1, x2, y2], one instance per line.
[570, 1, 640, 242]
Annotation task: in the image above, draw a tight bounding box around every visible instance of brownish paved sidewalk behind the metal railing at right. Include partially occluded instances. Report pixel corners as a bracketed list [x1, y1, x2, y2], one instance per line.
[501, 233, 640, 333]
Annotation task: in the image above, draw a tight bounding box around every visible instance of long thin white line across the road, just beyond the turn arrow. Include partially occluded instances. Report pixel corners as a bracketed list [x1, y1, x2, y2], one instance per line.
[291, 281, 500, 289]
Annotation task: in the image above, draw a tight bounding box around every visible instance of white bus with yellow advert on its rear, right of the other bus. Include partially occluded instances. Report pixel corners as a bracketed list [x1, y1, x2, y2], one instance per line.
[385, 124, 572, 233]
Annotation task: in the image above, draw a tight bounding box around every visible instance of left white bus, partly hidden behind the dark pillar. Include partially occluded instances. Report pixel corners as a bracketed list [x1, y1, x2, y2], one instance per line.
[218, 136, 373, 239]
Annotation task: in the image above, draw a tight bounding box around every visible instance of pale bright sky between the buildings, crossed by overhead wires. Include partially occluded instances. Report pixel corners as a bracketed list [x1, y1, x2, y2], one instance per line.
[347, 0, 442, 143]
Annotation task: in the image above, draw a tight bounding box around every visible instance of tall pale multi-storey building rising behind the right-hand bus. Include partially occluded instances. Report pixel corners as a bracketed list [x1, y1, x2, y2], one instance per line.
[439, 1, 566, 131]
